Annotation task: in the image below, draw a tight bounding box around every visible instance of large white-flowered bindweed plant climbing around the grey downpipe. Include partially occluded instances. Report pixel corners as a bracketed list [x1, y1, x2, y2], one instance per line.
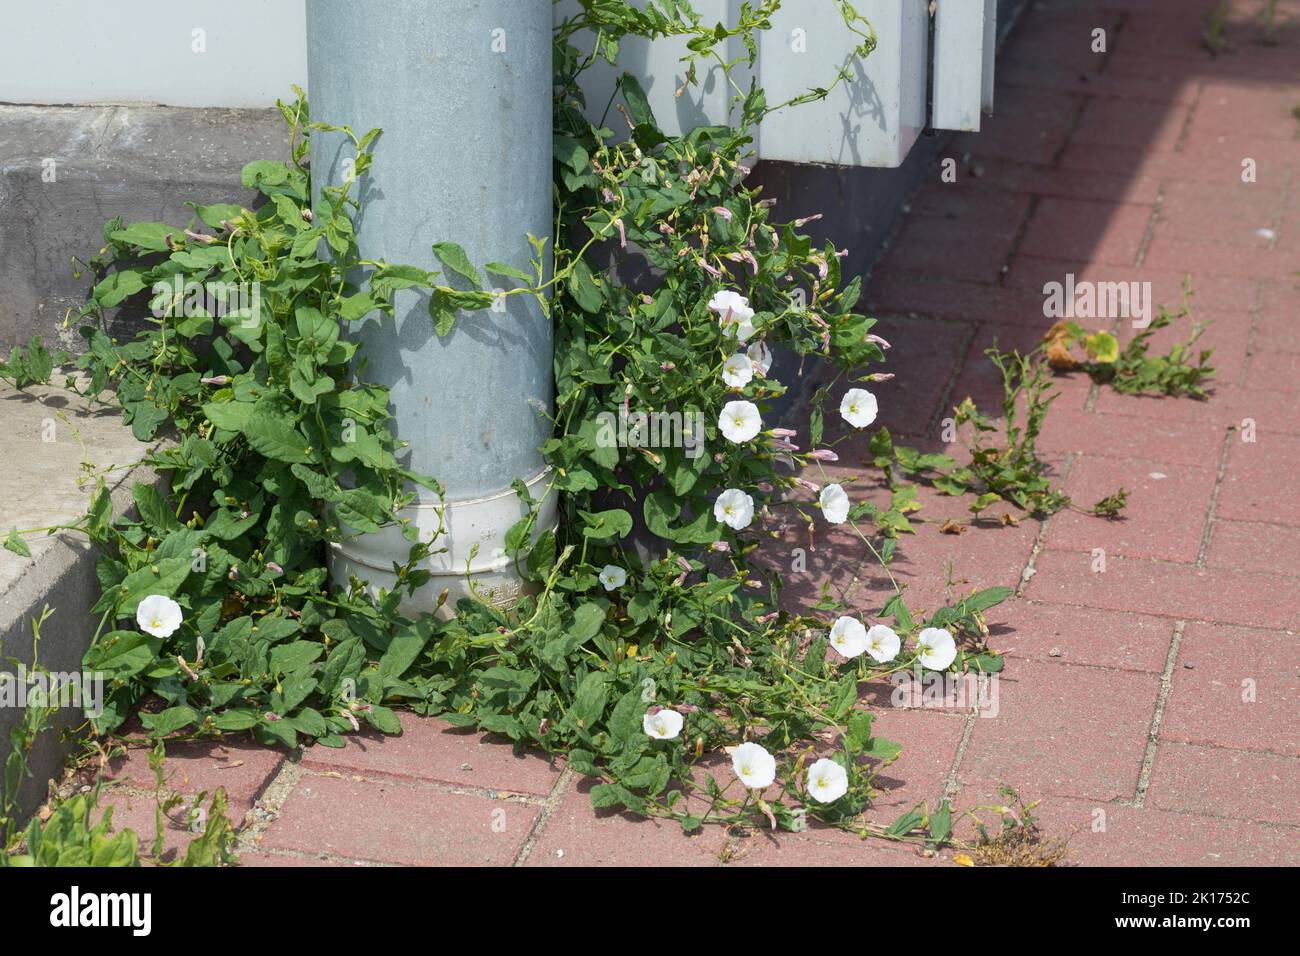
[2, 0, 1045, 845]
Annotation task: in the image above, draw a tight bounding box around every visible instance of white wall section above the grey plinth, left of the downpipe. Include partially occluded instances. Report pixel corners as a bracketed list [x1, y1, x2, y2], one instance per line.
[0, 0, 306, 107]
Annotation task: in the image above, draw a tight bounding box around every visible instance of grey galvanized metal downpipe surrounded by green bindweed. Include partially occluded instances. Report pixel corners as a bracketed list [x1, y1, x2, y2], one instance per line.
[307, 0, 555, 610]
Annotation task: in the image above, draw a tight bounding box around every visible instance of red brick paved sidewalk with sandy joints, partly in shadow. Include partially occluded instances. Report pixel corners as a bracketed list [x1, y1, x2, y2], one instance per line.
[89, 0, 1300, 866]
